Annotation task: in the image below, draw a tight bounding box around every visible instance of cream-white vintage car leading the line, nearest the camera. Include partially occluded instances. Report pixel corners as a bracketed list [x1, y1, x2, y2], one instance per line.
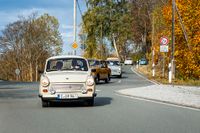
[39, 56, 96, 107]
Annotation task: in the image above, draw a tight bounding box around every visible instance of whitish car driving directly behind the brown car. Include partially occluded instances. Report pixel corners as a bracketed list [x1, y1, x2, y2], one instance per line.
[106, 58, 122, 78]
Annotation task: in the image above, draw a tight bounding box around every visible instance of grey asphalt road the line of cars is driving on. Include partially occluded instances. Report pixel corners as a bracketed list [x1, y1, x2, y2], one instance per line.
[0, 66, 200, 133]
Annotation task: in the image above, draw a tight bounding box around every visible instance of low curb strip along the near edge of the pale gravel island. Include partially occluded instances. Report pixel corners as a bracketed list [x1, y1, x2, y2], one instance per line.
[115, 91, 200, 111]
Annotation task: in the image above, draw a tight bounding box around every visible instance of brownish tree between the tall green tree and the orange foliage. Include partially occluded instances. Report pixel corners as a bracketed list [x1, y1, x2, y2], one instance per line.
[131, 0, 164, 55]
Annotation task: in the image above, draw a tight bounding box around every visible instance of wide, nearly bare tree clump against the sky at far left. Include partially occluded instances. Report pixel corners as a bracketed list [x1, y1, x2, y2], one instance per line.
[0, 13, 62, 81]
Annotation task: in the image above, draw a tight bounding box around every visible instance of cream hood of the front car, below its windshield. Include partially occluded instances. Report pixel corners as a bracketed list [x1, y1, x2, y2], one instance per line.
[45, 71, 89, 83]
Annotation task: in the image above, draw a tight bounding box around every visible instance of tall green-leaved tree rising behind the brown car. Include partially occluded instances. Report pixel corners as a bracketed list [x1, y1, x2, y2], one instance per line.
[82, 0, 132, 58]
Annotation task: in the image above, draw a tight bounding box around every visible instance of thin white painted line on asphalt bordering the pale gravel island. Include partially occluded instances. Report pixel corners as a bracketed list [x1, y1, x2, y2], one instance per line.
[115, 92, 200, 111]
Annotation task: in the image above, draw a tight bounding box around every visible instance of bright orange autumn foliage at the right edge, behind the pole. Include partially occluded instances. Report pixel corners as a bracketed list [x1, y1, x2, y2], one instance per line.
[154, 0, 200, 79]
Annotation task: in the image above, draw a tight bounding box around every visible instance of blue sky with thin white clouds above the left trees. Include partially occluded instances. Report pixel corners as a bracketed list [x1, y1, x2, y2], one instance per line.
[0, 0, 86, 54]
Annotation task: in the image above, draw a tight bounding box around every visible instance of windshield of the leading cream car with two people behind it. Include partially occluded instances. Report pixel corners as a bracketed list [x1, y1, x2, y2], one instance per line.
[46, 58, 88, 72]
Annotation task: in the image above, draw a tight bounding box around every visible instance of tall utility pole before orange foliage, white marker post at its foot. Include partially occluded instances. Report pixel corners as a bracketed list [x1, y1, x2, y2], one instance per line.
[169, 0, 176, 83]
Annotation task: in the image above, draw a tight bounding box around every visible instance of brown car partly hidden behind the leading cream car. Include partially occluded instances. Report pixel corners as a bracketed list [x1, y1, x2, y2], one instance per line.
[88, 59, 111, 84]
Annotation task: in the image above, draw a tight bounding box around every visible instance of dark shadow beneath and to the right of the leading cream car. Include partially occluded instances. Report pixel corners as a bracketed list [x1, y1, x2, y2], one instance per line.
[45, 97, 112, 108]
